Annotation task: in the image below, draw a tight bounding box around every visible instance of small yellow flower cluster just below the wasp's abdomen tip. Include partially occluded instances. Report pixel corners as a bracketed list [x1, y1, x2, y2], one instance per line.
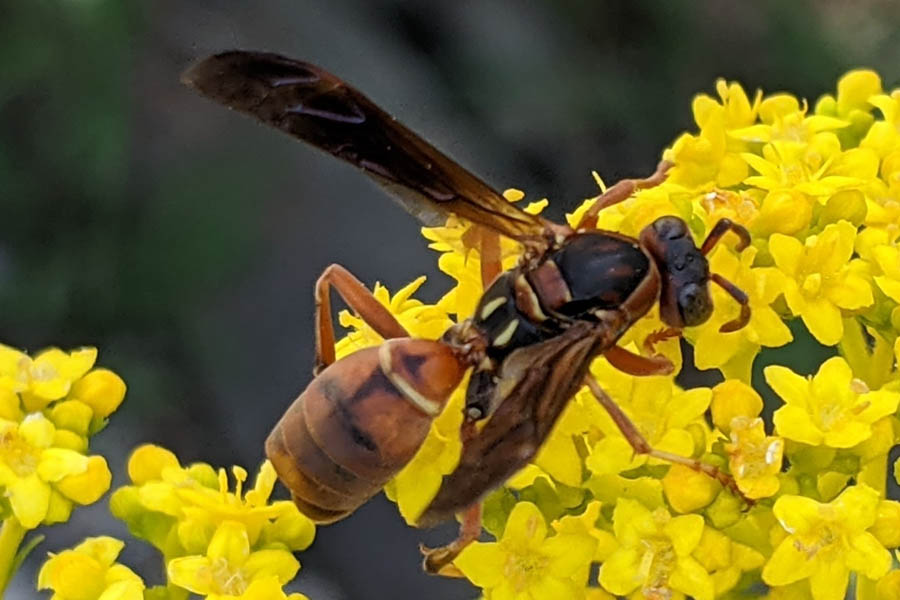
[110, 445, 315, 600]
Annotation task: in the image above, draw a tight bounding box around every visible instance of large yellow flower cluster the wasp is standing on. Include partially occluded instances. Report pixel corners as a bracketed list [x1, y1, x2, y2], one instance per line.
[338, 70, 900, 600]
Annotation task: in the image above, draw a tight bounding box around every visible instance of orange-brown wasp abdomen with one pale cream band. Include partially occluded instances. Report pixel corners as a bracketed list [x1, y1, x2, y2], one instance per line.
[266, 338, 464, 522]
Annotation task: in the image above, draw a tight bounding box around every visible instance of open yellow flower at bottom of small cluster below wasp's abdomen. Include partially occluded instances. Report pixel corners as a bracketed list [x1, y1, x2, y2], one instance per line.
[167, 521, 300, 600]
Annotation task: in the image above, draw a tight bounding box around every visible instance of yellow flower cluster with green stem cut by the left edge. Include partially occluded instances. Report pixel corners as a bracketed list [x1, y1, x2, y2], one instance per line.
[0, 344, 125, 593]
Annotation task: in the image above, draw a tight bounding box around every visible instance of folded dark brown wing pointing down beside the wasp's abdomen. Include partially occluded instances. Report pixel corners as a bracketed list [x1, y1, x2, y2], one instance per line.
[417, 322, 614, 527]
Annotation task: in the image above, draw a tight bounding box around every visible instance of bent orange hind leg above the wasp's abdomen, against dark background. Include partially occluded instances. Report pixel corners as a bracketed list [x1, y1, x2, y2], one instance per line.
[313, 264, 409, 375]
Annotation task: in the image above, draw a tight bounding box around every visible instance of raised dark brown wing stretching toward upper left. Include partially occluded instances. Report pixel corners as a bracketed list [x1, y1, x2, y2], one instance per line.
[182, 51, 545, 241]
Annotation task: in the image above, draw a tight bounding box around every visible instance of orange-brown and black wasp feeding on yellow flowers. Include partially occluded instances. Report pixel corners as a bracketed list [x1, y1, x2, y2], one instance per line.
[182, 51, 750, 574]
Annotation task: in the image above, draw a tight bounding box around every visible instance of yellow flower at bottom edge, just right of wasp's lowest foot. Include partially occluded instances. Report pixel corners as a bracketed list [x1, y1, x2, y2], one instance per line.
[454, 502, 596, 600]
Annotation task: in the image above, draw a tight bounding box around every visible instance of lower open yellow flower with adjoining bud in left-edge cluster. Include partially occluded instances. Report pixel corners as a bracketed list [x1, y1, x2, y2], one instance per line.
[0, 413, 112, 529]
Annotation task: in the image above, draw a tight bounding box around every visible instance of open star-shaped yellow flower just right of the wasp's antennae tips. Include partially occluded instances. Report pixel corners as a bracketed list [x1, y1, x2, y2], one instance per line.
[769, 221, 873, 345]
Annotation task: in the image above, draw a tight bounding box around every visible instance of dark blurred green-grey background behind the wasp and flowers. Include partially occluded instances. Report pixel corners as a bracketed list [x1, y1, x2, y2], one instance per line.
[0, 0, 900, 600]
